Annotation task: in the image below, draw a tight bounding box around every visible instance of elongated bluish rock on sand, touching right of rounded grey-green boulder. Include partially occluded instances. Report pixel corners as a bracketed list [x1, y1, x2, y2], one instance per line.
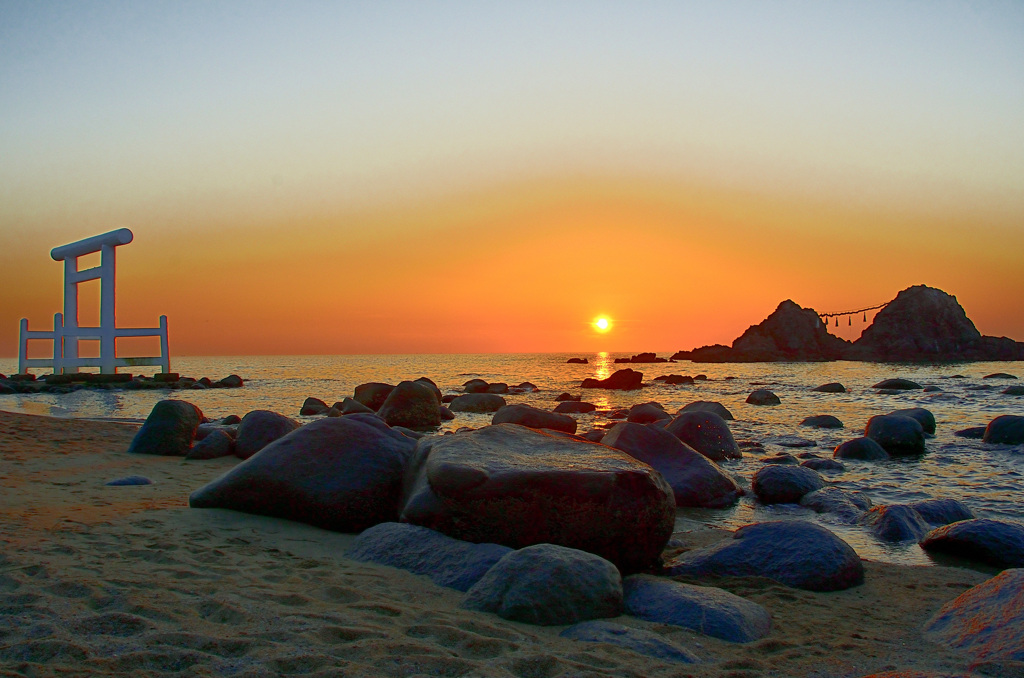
[623, 575, 771, 643]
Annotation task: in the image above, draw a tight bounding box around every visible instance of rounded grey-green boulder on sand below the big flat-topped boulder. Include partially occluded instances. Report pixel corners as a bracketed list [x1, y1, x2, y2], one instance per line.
[462, 544, 623, 626]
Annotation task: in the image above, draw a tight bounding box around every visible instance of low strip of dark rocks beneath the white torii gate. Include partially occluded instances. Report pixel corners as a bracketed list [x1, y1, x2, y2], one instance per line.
[0, 372, 245, 394]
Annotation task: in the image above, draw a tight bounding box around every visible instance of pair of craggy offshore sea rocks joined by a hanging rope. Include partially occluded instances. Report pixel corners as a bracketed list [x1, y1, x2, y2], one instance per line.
[672, 285, 1024, 363]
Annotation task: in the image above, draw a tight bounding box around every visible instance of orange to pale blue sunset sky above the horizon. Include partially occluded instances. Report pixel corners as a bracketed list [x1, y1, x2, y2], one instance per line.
[0, 0, 1024, 357]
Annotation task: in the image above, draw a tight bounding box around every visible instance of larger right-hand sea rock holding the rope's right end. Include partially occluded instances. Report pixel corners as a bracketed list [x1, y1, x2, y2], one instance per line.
[848, 285, 1021, 363]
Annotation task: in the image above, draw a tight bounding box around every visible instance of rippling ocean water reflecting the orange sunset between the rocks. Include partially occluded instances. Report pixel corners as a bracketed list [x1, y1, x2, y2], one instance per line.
[0, 353, 1024, 564]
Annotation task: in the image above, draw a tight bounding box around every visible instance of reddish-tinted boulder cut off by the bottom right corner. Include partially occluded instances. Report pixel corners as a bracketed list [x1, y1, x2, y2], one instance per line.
[924, 569, 1024, 675]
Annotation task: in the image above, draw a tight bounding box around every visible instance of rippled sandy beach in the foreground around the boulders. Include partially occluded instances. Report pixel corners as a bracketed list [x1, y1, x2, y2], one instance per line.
[0, 413, 988, 678]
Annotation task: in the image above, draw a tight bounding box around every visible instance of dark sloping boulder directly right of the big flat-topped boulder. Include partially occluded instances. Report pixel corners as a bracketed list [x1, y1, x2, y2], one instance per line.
[601, 422, 743, 508]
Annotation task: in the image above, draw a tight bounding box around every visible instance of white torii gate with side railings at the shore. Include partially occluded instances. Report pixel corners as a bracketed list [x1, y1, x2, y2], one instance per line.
[17, 228, 171, 374]
